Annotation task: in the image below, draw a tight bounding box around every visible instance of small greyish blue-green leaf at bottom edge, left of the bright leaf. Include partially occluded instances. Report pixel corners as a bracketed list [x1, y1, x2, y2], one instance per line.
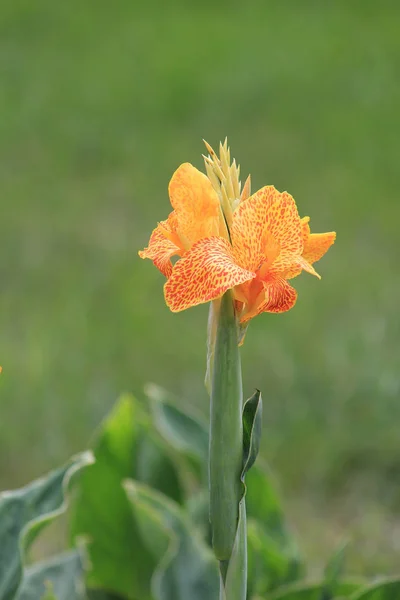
[17, 551, 86, 600]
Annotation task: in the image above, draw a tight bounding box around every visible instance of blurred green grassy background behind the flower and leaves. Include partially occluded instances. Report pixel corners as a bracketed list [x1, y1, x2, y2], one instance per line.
[0, 0, 400, 573]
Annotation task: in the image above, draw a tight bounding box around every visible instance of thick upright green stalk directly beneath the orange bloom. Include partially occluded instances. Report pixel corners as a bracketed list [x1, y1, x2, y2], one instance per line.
[209, 291, 247, 600]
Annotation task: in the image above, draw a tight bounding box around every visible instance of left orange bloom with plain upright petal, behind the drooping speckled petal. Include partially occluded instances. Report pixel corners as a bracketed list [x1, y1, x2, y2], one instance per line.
[139, 163, 221, 277]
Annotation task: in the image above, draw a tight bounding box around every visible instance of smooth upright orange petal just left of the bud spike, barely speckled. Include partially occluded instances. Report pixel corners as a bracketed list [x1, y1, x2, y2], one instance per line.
[168, 163, 220, 250]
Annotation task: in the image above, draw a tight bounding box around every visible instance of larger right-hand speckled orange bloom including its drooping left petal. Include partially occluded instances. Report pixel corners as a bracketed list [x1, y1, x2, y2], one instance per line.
[165, 186, 335, 323]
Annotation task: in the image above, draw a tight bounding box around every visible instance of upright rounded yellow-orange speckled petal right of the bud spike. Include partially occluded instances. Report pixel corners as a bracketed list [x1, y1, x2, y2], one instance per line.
[231, 186, 303, 270]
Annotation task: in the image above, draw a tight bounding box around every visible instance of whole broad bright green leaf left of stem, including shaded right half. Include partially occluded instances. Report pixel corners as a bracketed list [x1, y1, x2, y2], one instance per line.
[71, 396, 182, 600]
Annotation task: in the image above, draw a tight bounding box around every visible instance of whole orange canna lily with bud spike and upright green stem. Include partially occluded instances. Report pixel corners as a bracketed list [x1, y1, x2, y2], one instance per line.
[139, 140, 336, 600]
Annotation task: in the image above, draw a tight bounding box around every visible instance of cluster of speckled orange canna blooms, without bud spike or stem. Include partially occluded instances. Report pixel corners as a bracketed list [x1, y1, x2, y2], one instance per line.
[139, 145, 336, 324]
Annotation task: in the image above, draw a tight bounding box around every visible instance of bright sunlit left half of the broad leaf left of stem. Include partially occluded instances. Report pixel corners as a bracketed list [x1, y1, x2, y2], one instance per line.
[71, 397, 153, 600]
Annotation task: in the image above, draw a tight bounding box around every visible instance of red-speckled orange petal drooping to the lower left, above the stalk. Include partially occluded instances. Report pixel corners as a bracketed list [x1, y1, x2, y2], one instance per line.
[164, 237, 255, 312]
